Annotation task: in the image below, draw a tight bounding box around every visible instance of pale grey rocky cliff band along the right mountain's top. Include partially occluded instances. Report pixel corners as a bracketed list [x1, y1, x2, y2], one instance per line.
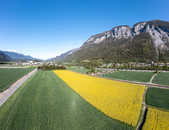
[83, 20, 169, 48]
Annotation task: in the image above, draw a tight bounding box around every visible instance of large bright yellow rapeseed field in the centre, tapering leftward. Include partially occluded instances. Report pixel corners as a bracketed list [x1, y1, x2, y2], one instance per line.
[55, 70, 145, 126]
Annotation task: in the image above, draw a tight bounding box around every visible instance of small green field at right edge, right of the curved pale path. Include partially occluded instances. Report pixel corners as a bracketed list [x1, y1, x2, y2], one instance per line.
[153, 72, 169, 85]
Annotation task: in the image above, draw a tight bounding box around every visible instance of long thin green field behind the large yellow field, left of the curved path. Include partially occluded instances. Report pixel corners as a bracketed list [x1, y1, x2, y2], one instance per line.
[103, 71, 154, 82]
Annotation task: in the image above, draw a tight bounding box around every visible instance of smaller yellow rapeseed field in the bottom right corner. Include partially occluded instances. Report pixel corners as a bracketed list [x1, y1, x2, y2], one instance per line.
[143, 108, 169, 130]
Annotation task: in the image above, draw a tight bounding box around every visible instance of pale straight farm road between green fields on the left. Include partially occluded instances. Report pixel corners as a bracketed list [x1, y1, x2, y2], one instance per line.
[0, 69, 37, 107]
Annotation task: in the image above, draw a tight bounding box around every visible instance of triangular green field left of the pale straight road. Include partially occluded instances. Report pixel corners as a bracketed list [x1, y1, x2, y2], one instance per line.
[0, 68, 33, 92]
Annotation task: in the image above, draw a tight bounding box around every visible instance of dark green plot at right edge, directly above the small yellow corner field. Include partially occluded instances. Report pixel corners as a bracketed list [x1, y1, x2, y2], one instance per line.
[146, 88, 169, 110]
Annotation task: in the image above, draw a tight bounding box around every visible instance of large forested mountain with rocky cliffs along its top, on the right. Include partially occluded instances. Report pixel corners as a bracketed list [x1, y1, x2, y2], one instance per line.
[54, 20, 169, 62]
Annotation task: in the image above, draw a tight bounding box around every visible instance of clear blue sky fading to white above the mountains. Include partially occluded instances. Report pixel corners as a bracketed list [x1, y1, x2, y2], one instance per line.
[0, 0, 169, 59]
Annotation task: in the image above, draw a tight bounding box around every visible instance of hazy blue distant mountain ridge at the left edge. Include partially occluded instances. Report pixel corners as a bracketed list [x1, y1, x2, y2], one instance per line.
[0, 51, 39, 62]
